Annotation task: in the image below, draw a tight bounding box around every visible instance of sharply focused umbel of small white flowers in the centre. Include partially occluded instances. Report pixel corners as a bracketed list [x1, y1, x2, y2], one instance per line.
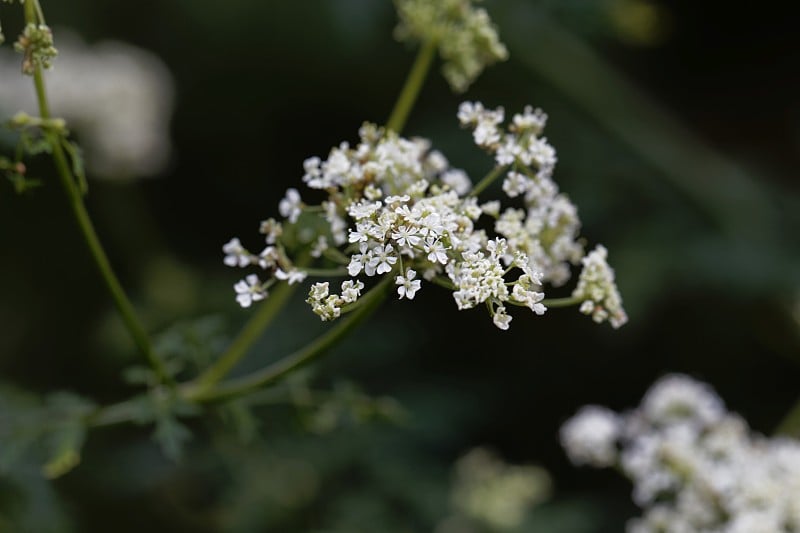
[223, 102, 626, 329]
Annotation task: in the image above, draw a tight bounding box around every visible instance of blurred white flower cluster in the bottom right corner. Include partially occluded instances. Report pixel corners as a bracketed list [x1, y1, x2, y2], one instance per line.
[561, 375, 800, 533]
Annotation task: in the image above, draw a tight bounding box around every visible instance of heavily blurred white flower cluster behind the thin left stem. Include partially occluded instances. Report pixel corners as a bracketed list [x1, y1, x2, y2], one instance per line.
[0, 30, 174, 178]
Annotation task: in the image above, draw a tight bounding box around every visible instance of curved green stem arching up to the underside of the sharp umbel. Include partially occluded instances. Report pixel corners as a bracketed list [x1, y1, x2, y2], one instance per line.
[184, 276, 394, 402]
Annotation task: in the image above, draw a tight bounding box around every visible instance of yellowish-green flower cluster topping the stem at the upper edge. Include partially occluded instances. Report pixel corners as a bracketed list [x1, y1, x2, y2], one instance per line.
[395, 0, 508, 92]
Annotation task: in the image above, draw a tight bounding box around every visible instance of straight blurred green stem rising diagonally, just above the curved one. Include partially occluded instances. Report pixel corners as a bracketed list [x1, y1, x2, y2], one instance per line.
[194, 283, 297, 391]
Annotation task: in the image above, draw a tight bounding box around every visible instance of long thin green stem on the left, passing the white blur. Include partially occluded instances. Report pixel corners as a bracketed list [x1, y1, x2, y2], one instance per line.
[25, 0, 171, 382]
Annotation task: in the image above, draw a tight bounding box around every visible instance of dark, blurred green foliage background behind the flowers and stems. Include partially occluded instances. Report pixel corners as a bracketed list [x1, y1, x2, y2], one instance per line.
[0, 0, 800, 533]
